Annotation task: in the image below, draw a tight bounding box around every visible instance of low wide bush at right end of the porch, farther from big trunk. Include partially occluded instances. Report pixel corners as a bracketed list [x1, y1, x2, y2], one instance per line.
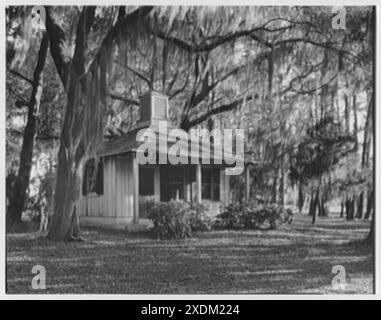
[214, 202, 292, 229]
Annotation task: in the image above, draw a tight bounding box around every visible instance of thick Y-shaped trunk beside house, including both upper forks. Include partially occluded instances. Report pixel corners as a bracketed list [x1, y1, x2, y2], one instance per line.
[46, 7, 88, 241]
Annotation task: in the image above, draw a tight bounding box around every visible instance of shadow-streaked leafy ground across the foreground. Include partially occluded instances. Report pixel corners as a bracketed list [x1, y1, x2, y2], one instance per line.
[7, 216, 373, 294]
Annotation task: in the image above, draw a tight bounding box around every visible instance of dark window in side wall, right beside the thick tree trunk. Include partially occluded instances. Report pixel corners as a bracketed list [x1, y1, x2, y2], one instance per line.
[82, 159, 103, 196]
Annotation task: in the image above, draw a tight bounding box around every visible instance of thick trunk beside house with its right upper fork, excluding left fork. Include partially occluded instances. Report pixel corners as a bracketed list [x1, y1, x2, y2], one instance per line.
[47, 7, 95, 241]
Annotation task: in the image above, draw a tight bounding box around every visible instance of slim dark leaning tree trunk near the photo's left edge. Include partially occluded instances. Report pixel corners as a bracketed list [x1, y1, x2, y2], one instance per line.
[7, 33, 49, 223]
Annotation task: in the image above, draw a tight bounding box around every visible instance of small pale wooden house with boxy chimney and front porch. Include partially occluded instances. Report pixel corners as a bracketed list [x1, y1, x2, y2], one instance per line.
[79, 92, 249, 230]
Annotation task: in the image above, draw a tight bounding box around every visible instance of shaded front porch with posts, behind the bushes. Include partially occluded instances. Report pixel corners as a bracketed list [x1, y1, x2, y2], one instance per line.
[138, 164, 230, 223]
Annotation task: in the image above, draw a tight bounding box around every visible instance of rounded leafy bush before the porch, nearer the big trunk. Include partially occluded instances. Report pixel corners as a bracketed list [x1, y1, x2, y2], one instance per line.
[149, 200, 212, 239]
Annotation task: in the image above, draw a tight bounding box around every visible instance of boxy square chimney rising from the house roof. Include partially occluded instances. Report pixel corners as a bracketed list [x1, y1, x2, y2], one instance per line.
[137, 91, 168, 128]
